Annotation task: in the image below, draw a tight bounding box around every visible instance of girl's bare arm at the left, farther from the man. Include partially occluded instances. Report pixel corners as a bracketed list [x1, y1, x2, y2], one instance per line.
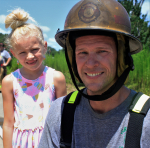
[2, 75, 14, 148]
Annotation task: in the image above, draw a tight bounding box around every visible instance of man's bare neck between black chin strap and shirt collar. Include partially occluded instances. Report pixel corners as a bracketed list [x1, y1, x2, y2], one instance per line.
[90, 86, 130, 114]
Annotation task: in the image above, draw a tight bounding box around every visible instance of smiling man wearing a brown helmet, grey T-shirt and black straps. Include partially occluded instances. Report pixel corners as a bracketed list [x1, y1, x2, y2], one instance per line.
[39, 0, 150, 148]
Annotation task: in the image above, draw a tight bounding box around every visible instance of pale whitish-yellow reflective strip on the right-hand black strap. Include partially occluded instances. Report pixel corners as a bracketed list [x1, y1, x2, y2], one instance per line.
[132, 94, 149, 113]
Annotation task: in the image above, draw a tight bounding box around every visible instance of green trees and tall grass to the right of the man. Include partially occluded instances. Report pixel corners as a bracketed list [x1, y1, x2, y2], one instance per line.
[118, 0, 150, 95]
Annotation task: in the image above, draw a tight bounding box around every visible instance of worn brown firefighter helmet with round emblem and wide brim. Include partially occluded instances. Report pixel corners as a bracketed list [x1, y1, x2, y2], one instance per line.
[55, 0, 142, 54]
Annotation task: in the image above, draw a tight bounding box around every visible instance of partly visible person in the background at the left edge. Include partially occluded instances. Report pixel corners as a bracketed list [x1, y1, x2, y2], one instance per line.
[0, 43, 11, 90]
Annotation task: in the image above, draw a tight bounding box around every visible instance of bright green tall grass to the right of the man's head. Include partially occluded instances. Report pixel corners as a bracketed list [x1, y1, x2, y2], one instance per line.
[127, 46, 150, 95]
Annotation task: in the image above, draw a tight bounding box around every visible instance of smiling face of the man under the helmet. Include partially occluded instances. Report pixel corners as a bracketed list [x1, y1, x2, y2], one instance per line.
[75, 35, 117, 95]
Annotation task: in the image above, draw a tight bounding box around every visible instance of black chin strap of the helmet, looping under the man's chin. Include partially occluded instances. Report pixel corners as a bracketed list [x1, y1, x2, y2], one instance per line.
[65, 45, 134, 101]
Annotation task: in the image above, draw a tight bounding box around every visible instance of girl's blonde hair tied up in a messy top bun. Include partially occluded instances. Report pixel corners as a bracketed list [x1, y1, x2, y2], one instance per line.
[5, 8, 44, 49]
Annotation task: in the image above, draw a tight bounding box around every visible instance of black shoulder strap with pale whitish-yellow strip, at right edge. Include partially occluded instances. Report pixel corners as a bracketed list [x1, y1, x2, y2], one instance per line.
[125, 92, 150, 148]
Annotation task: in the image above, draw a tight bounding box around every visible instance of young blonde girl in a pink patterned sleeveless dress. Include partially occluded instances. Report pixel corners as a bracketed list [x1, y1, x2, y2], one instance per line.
[2, 9, 67, 148]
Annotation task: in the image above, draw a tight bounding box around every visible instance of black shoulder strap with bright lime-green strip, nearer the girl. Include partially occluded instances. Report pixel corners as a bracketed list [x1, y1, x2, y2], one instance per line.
[60, 91, 81, 148]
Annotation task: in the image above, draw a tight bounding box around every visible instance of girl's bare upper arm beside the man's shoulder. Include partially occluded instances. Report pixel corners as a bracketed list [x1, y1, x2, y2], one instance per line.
[54, 71, 67, 98]
